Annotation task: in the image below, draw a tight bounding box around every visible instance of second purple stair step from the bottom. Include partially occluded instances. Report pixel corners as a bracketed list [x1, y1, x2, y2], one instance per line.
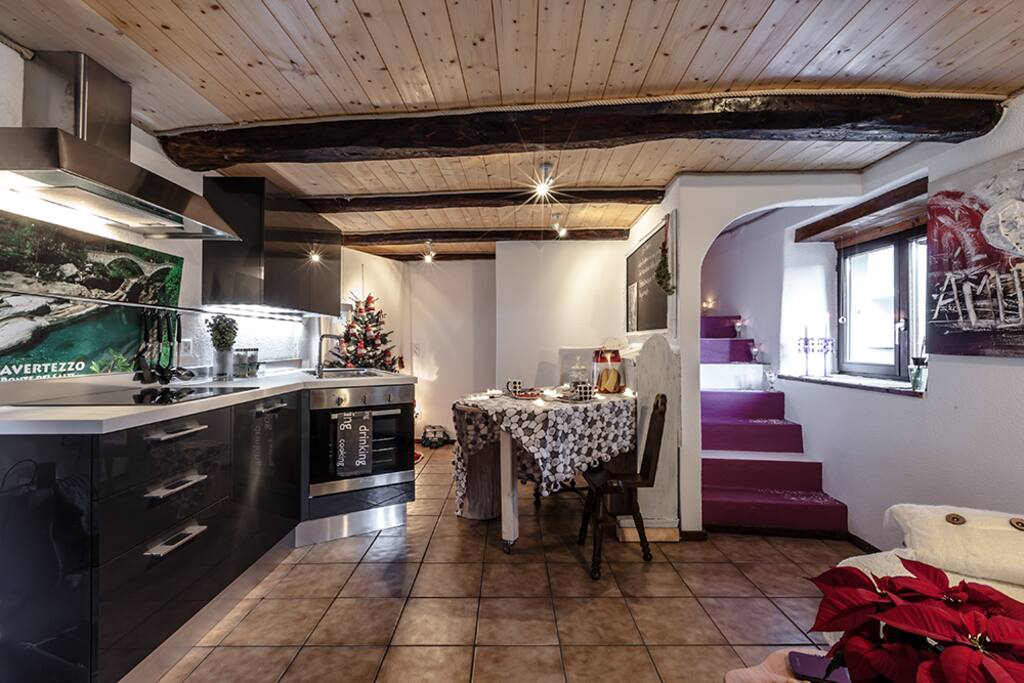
[700, 458, 821, 492]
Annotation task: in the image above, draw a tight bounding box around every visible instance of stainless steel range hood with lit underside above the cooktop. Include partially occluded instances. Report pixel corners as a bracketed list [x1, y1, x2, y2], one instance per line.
[0, 52, 239, 240]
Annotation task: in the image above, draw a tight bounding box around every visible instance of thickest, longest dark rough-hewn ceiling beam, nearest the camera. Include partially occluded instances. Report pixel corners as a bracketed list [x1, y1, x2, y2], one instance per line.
[160, 94, 1002, 171]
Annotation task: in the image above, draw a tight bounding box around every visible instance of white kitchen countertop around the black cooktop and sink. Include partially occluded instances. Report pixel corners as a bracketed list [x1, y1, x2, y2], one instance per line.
[0, 370, 416, 434]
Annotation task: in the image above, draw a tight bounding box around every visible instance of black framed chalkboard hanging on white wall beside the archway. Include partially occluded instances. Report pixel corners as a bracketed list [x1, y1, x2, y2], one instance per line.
[626, 214, 675, 332]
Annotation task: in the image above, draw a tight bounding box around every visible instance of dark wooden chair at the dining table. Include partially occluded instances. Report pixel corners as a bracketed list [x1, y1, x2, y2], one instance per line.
[577, 393, 668, 581]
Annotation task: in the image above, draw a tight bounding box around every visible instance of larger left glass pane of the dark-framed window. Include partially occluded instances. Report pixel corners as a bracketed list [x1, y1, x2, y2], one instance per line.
[844, 244, 896, 367]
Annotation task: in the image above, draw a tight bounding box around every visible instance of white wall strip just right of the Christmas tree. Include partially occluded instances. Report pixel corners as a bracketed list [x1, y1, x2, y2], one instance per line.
[409, 261, 496, 435]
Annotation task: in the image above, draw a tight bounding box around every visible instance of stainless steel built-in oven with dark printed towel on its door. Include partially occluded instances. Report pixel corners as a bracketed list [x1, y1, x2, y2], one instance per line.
[309, 384, 415, 508]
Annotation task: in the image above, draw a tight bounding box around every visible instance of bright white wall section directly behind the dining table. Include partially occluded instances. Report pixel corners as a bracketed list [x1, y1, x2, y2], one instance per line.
[493, 241, 626, 387]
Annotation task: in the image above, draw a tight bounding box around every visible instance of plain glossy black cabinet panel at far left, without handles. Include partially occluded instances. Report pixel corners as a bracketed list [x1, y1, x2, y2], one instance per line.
[0, 436, 93, 683]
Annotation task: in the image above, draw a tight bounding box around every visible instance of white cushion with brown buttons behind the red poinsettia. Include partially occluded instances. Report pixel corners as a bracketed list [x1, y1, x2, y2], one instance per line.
[886, 504, 1024, 586]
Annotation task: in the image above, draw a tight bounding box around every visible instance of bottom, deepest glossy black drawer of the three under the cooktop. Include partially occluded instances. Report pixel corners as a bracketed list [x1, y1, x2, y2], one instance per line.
[94, 500, 239, 683]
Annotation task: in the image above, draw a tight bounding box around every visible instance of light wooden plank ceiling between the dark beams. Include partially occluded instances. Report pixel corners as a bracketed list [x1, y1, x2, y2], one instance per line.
[0, 0, 1024, 259]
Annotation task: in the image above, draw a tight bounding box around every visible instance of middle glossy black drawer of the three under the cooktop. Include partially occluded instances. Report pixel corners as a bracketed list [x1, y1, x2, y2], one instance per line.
[93, 450, 231, 564]
